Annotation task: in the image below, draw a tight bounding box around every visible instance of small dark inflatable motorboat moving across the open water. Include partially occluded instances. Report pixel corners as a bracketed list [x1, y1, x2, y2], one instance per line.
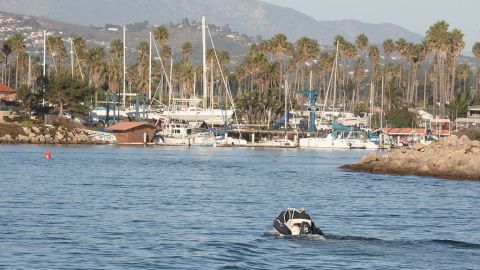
[273, 208, 323, 236]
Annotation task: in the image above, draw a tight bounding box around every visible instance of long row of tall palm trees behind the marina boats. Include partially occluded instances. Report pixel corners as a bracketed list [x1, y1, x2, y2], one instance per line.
[0, 21, 480, 123]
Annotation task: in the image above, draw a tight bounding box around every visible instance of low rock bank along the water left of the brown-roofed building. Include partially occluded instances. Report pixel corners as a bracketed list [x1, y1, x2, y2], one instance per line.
[0, 124, 97, 144]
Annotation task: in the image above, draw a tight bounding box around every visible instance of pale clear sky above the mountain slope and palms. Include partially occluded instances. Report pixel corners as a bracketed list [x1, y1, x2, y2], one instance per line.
[263, 0, 480, 55]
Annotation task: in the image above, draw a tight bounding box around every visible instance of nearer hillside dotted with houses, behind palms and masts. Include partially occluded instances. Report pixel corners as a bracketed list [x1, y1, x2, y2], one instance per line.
[0, 12, 254, 64]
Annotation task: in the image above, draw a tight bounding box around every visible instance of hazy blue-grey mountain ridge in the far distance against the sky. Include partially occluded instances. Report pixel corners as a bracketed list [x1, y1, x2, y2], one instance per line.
[0, 0, 420, 44]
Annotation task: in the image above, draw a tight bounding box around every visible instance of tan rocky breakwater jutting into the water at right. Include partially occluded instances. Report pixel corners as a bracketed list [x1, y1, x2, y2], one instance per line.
[340, 135, 480, 180]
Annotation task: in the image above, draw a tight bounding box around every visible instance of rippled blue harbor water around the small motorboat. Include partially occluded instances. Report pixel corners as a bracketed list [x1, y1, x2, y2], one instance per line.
[0, 145, 480, 269]
